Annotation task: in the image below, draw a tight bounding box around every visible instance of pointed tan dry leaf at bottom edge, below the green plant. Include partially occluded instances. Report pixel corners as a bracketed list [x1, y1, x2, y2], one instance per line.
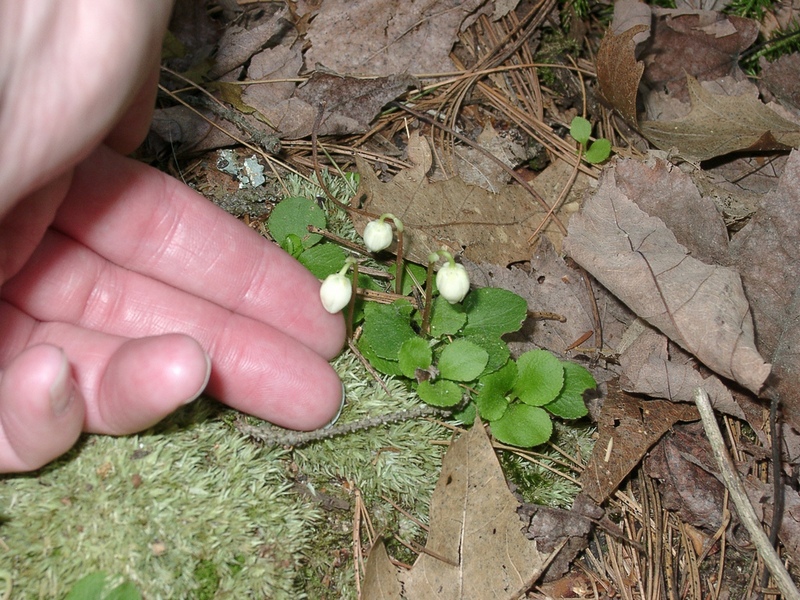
[402, 421, 548, 600]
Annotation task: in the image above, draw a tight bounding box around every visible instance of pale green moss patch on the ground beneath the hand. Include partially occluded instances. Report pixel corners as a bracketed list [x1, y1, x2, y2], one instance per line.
[0, 355, 447, 599]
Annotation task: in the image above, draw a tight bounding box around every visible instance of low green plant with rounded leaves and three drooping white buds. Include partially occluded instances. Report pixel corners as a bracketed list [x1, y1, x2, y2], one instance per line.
[269, 193, 596, 447]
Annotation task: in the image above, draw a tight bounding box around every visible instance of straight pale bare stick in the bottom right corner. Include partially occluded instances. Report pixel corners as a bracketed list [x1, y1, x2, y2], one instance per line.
[694, 388, 800, 600]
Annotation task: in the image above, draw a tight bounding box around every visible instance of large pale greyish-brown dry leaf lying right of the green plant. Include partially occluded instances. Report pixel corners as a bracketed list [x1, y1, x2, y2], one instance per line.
[565, 158, 770, 393]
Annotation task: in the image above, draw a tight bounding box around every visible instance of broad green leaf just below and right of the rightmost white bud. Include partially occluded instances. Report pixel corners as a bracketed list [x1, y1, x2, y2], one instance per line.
[463, 288, 528, 337]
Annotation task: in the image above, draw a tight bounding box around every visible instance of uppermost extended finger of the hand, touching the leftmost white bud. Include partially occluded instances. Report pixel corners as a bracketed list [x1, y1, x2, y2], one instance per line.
[54, 148, 344, 358]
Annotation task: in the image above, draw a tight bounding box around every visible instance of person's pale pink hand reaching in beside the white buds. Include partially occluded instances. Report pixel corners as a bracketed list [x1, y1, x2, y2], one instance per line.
[0, 0, 345, 472]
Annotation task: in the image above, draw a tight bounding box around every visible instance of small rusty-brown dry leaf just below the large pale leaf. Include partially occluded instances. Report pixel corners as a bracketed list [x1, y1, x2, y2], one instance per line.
[580, 382, 699, 504]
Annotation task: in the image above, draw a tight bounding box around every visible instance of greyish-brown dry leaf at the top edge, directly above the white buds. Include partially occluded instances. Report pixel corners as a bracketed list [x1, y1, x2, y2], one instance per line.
[306, 0, 484, 76]
